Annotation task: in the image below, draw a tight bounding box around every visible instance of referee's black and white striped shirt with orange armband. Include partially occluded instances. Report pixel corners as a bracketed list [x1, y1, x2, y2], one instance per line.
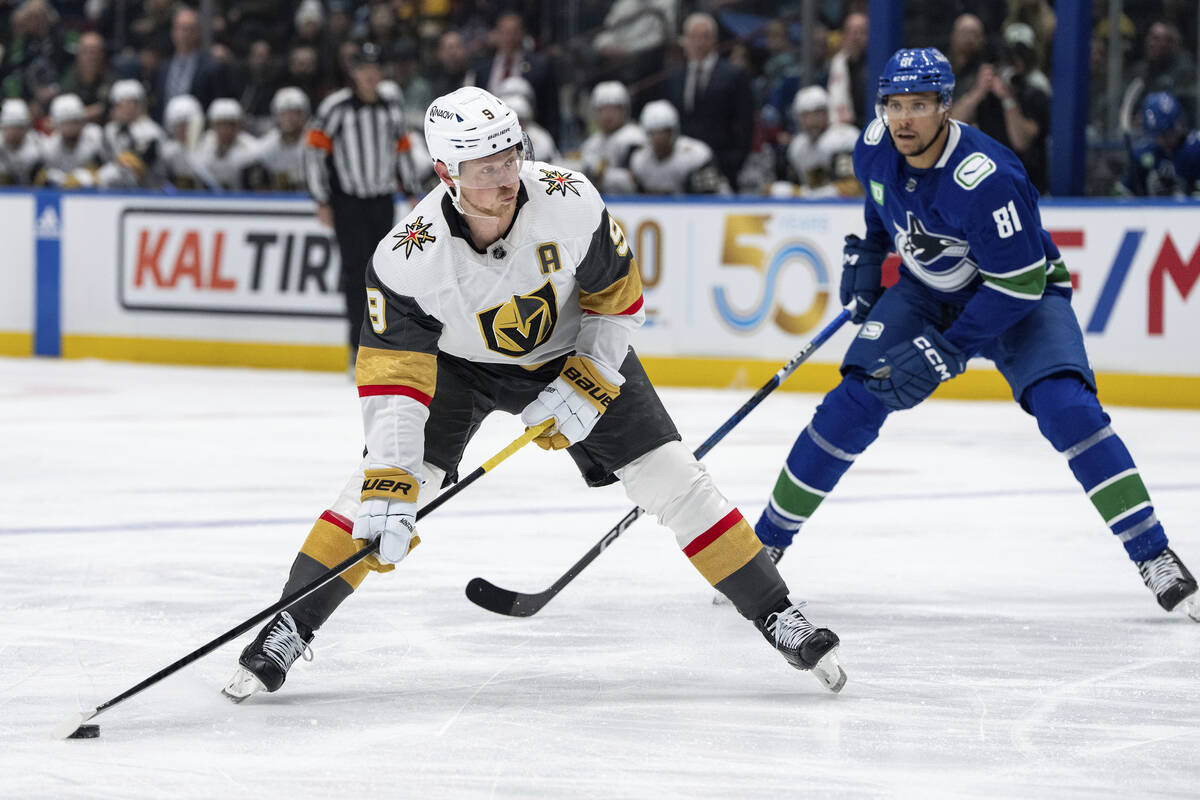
[305, 89, 408, 204]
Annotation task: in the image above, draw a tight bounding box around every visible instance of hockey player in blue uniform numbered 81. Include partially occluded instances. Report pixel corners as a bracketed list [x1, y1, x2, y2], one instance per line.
[755, 48, 1200, 621]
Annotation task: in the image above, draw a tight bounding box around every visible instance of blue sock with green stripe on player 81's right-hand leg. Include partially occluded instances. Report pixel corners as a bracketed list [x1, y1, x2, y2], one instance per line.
[1025, 375, 1166, 561]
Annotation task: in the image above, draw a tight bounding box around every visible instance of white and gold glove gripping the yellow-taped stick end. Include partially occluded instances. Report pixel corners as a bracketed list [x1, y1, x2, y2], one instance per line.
[521, 355, 624, 450]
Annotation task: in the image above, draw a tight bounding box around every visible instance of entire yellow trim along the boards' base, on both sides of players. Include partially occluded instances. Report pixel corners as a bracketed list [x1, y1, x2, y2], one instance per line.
[32, 333, 1200, 409]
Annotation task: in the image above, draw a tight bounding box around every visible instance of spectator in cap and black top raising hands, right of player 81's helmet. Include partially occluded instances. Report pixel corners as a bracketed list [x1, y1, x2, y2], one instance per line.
[954, 23, 1050, 192]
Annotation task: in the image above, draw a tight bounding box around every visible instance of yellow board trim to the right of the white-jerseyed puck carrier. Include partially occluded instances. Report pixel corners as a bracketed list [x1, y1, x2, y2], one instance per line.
[642, 356, 1200, 409]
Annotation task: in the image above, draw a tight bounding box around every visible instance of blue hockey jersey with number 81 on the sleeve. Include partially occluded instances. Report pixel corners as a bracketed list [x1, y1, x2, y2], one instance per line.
[854, 119, 1070, 354]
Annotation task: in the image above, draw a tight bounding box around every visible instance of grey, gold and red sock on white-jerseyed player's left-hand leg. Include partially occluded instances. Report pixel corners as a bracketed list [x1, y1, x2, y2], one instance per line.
[274, 511, 371, 631]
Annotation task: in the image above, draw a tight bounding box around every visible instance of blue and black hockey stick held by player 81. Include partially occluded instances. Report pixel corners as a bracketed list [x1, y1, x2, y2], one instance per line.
[467, 309, 850, 616]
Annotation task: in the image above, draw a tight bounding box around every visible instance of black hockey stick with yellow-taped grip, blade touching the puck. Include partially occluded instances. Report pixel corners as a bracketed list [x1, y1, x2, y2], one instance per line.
[54, 420, 553, 739]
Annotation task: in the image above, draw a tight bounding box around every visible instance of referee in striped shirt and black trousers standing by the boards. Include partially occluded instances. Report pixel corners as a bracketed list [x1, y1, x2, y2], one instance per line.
[305, 42, 412, 359]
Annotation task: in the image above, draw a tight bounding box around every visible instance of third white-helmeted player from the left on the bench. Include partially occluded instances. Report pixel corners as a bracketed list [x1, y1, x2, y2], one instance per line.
[96, 79, 167, 188]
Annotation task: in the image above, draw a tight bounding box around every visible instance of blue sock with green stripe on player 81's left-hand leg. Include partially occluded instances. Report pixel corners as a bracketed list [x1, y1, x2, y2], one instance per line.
[755, 374, 888, 547]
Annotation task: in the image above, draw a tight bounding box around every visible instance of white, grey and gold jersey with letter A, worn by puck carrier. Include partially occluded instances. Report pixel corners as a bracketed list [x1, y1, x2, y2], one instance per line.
[355, 162, 644, 475]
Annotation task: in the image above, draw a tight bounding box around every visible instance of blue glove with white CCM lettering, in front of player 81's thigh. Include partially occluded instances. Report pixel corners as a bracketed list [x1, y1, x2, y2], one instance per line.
[863, 326, 967, 411]
